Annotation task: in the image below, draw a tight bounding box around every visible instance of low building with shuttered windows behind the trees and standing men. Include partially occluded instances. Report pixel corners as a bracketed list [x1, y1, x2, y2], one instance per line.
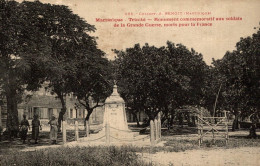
[0, 85, 147, 128]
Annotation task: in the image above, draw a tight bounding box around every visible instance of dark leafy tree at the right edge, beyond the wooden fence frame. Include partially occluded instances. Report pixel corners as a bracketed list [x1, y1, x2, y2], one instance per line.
[213, 27, 260, 130]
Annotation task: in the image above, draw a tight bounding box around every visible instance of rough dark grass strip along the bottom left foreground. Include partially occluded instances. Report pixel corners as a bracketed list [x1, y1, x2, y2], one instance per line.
[0, 147, 148, 166]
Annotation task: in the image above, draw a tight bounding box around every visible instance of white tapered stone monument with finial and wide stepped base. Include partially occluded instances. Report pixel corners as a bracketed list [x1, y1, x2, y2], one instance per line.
[79, 85, 147, 143]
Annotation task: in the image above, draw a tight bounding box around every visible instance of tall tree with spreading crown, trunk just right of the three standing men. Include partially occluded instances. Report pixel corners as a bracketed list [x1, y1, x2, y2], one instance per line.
[16, 1, 96, 130]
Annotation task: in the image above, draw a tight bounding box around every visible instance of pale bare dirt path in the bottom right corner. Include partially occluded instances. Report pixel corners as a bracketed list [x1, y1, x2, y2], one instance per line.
[142, 147, 260, 166]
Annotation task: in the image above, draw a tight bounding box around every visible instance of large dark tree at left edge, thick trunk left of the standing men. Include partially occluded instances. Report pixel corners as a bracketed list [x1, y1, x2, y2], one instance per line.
[0, 0, 49, 135]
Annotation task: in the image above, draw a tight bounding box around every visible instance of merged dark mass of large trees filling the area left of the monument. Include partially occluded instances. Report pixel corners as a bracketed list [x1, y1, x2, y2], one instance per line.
[0, 1, 109, 132]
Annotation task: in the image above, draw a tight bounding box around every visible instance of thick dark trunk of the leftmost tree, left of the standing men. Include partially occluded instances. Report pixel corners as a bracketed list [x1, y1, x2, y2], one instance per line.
[6, 89, 19, 138]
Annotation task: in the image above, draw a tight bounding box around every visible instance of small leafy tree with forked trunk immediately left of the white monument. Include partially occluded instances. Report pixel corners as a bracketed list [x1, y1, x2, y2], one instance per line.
[69, 51, 113, 134]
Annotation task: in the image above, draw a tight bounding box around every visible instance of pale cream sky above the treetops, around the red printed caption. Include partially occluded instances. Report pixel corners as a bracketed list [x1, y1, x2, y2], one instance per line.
[18, 0, 260, 65]
